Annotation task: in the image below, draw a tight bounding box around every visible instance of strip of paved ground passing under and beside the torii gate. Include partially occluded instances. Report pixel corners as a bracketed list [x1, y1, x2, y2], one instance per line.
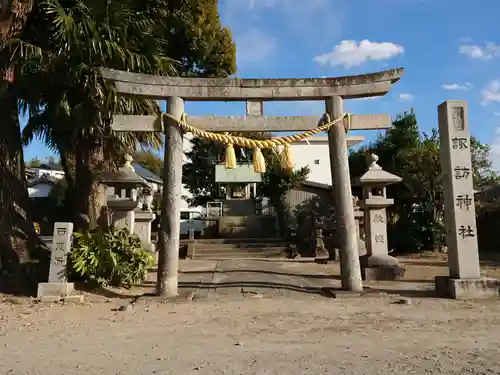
[137, 259, 446, 297]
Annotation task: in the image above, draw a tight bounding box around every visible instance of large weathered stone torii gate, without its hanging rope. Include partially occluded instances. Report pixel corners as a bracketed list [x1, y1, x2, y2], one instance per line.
[101, 69, 403, 297]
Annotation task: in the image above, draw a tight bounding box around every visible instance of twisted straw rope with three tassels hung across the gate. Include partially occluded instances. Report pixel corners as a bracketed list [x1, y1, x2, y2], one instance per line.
[162, 113, 351, 173]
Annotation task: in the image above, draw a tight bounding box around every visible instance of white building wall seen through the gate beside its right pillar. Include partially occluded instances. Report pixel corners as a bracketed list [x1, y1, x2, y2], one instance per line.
[290, 137, 332, 185]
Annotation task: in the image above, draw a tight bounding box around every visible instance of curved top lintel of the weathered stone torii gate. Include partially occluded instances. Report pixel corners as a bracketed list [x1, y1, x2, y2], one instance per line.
[101, 68, 403, 101]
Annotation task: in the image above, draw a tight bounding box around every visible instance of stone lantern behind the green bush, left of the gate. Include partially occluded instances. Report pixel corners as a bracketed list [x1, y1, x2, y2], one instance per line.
[101, 155, 148, 233]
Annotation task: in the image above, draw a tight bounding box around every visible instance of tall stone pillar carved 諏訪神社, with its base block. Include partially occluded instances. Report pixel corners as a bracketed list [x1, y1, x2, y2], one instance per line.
[436, 100, 500, 298]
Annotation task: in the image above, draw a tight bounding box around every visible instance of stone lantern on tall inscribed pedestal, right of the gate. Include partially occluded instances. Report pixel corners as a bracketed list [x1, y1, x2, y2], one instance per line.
[357, 154, 404, 280]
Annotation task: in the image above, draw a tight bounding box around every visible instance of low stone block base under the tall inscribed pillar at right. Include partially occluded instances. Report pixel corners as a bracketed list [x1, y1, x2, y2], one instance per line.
[434, 276, 500, 299]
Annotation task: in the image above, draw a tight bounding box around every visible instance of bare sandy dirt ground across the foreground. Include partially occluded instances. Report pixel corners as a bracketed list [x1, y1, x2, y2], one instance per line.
[0, 294, 500, 375]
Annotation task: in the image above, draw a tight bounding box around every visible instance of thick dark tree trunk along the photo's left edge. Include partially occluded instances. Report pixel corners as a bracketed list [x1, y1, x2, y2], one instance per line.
[0, 0, 48, 288]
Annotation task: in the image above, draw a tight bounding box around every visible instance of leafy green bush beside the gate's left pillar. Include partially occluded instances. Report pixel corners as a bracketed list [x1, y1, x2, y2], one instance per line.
[68, 227, 153, 288]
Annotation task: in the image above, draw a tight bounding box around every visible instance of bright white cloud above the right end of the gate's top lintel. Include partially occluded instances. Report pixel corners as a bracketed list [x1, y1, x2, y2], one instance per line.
[314, 40, 404, 68]
